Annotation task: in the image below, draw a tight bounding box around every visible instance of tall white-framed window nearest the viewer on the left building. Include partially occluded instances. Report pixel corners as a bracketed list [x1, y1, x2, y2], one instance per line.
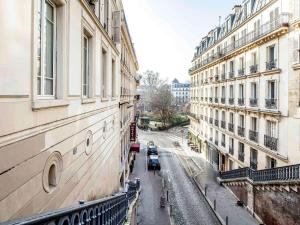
[37, 0, 57, 98]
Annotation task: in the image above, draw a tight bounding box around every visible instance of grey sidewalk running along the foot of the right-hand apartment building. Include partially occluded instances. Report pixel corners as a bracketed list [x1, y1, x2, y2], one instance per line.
[181, 140, 260, 225]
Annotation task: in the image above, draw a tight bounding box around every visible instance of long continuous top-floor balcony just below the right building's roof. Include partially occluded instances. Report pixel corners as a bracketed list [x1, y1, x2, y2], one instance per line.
[189, 13, 289, 73]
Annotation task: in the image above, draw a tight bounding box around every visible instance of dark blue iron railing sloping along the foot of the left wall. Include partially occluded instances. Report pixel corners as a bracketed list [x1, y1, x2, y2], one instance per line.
[4, 180, 140, 225]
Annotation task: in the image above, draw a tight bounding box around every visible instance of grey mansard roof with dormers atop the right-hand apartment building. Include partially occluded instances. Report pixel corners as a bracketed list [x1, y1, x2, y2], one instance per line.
[195, 0, 271, 57]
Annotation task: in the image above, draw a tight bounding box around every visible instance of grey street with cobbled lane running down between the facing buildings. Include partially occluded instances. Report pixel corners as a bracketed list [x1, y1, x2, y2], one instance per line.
[133, 131, 220, 225]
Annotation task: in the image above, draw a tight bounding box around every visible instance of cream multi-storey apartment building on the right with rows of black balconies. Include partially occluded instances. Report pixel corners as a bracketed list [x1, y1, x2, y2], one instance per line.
[189, 0, 300, 171]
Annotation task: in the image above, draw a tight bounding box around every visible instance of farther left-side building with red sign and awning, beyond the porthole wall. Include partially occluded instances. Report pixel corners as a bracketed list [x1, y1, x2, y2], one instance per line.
[119, 11, 140, 185]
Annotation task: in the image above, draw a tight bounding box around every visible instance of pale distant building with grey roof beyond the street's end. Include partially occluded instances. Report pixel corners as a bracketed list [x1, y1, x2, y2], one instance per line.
[171, 78, 190, 105]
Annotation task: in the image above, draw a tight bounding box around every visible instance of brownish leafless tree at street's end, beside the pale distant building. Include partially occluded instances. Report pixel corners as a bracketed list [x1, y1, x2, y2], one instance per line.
[151, 84, 173, 126]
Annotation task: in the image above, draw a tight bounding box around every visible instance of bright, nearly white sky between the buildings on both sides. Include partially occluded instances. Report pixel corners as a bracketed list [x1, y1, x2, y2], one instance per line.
[123, 0, 242, 82]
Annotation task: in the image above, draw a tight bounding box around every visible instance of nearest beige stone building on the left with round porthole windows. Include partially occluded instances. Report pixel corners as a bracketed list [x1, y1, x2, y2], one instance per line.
[0, 0, 137, 221]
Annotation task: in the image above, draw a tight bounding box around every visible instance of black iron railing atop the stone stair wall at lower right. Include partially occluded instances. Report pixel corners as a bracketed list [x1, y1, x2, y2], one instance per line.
[220, 163, 300, 182]
